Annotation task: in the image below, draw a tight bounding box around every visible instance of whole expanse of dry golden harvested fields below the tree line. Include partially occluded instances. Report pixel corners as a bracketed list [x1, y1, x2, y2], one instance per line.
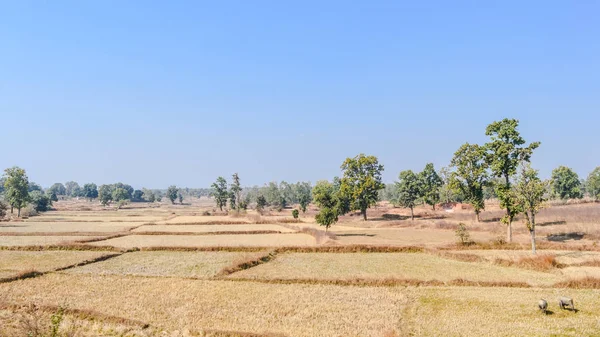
[0, 200, 600, 337]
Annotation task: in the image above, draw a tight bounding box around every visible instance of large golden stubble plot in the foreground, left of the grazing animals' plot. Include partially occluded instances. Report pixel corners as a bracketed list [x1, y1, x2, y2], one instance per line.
[0, 274, 406, 337]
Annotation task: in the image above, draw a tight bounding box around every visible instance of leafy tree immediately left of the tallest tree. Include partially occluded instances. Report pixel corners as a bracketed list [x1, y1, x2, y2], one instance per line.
[450, 143, 489, 222]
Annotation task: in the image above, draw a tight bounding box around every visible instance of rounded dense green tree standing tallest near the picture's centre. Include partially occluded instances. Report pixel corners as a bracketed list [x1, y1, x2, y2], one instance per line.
[340, 153, 385, 221]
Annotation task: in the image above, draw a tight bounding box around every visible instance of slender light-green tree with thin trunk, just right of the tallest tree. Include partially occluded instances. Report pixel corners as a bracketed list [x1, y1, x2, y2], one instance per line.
[515, 163, 548, 254]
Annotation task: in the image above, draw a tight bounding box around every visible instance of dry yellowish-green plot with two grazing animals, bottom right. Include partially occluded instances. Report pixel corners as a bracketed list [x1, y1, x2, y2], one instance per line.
[407, 287, 600, 336]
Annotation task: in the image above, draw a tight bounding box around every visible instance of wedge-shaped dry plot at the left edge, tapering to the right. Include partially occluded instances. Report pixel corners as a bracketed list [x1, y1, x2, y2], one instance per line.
[0, 251, 113, 277]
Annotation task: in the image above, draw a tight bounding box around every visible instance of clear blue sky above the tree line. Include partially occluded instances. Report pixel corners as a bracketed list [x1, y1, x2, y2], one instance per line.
[0, 0, 600, 188]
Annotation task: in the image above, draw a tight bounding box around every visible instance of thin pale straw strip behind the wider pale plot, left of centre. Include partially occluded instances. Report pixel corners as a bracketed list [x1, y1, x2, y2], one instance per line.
[133, 225, 296, 233]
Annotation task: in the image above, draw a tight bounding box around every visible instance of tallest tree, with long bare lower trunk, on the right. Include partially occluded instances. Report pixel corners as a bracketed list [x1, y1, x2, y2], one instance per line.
[485, 118, 540, 242]
